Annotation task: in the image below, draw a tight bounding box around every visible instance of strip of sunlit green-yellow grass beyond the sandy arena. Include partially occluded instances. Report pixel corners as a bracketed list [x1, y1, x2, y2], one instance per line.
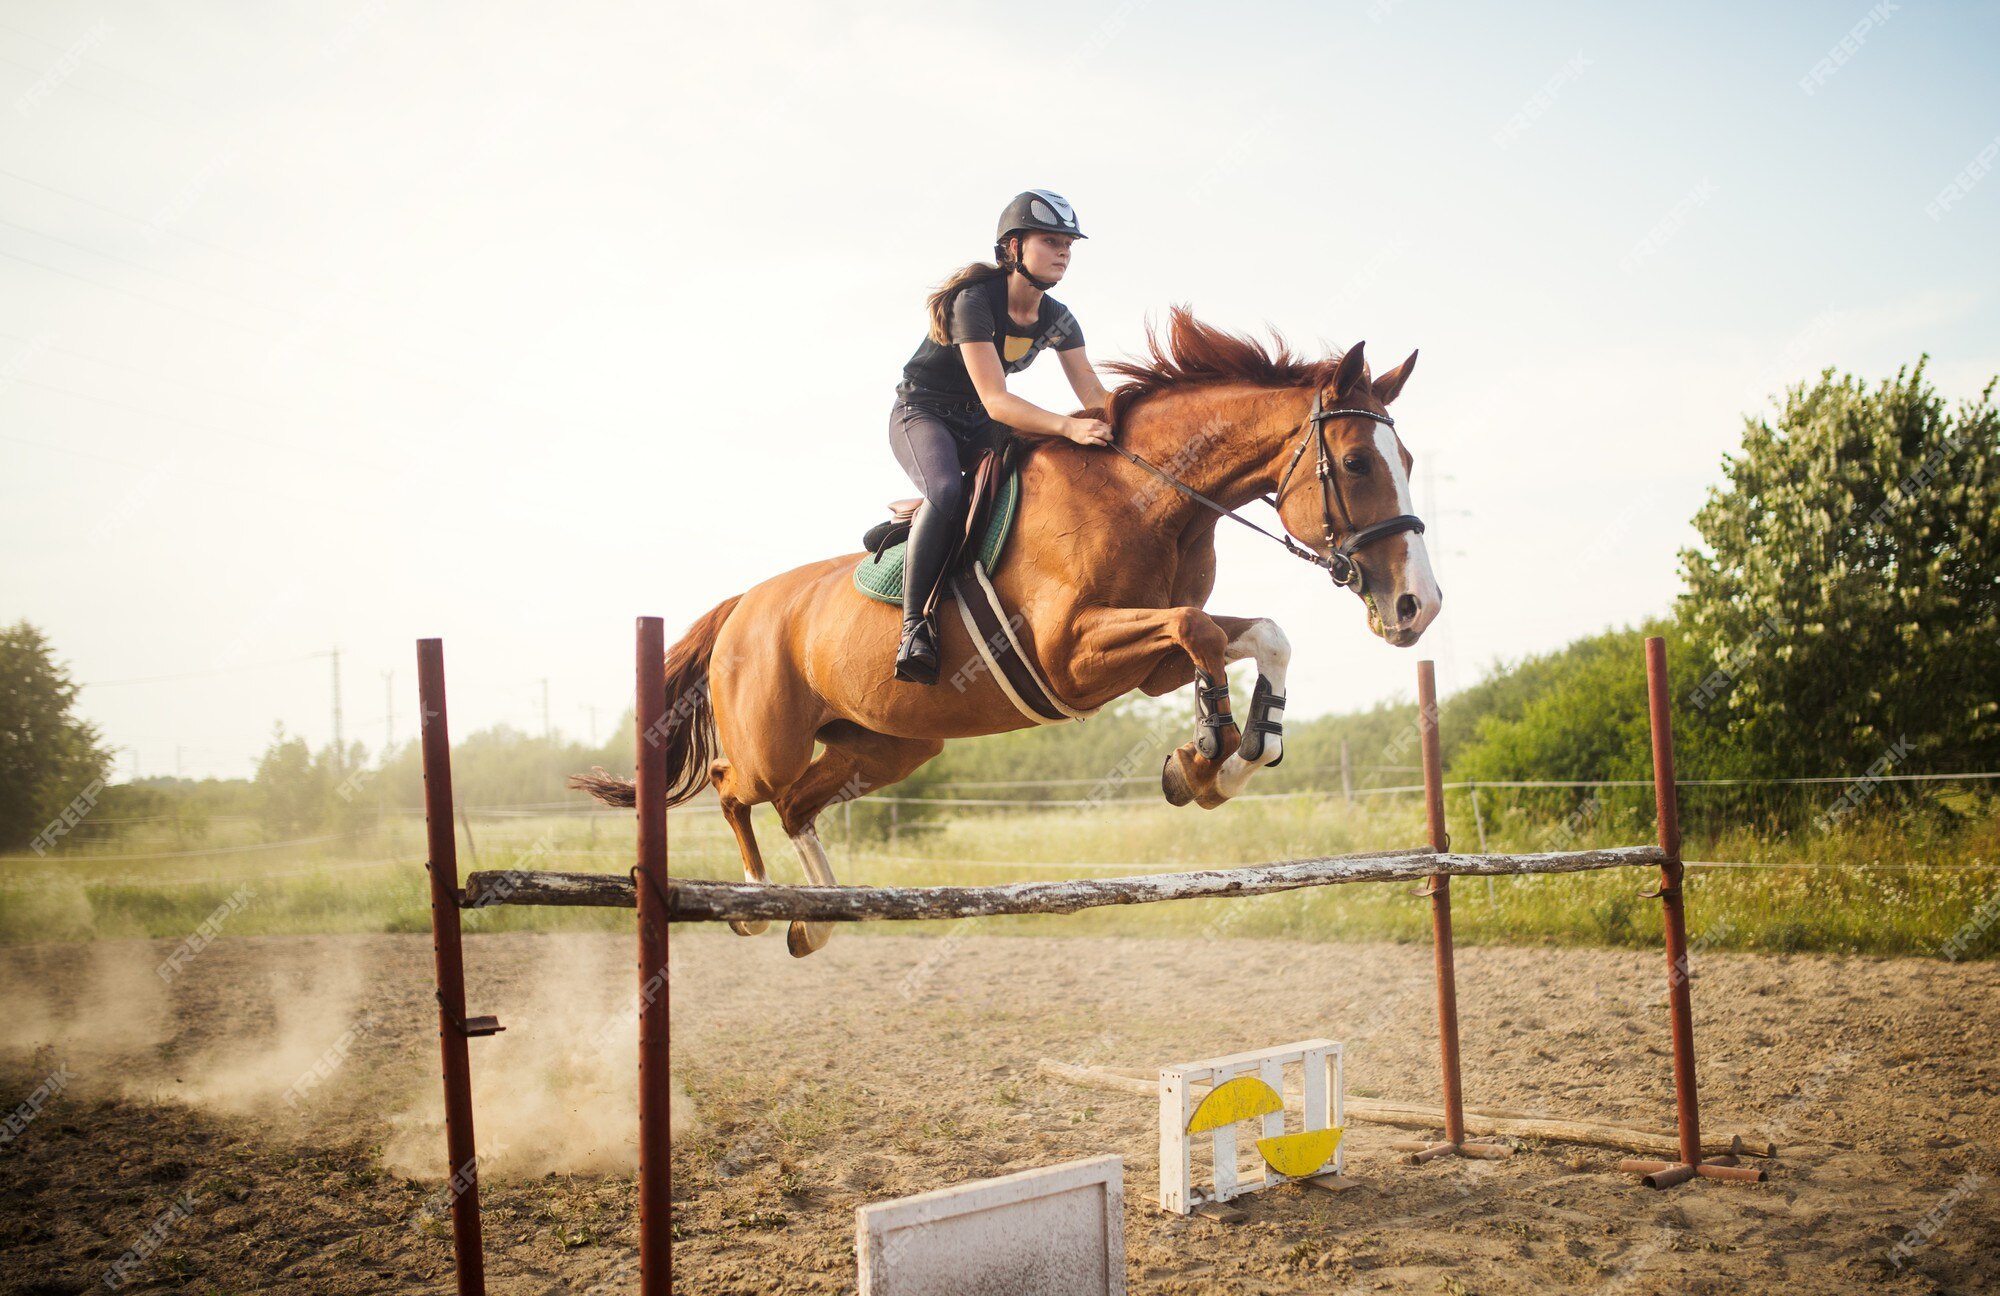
[0, 792, 2000, 958]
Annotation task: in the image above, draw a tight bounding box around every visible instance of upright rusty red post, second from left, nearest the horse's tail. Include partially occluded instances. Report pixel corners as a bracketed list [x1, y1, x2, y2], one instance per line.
[636, 616, 674, 1296]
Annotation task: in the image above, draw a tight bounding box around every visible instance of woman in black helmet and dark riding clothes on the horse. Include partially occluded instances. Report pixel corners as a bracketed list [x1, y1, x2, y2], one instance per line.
[888, 190, 1112, 684]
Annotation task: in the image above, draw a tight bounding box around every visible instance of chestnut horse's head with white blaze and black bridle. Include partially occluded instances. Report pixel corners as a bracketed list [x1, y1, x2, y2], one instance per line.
[1276, 342, 1444, 648]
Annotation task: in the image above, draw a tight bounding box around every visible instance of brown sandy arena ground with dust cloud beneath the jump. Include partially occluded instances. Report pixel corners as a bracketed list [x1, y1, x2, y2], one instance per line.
[0, 926, 2000, 1296]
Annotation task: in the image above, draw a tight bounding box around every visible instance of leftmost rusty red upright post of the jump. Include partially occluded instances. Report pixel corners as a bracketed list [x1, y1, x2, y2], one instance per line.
[416, 640, 486, 1296]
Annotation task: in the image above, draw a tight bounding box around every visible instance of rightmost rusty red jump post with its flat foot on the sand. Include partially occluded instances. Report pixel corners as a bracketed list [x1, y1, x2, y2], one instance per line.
[1618, 636, 1766, 1188]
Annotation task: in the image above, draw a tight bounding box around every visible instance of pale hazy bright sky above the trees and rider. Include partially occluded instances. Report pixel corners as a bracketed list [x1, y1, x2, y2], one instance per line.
[0, 0, 2000, 778]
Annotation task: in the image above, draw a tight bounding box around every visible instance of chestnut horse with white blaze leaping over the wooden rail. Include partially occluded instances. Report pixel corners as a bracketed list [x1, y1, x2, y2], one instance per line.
[570, 306, 1442, 958]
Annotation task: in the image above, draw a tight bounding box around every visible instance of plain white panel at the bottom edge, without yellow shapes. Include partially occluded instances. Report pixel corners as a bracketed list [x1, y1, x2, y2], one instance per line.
[854, 1156, 1124, 1296]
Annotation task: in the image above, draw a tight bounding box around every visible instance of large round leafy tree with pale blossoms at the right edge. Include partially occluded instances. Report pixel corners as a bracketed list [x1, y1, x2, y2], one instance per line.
[1678, 360, 2000, 774]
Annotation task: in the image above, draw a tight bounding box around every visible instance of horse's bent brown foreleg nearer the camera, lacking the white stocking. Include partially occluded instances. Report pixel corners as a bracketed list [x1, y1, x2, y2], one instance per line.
[1072, 608, 1242, 810]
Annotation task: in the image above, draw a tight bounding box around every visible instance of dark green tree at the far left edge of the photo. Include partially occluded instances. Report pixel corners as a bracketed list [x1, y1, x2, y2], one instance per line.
[0, 620, 112, 850]
